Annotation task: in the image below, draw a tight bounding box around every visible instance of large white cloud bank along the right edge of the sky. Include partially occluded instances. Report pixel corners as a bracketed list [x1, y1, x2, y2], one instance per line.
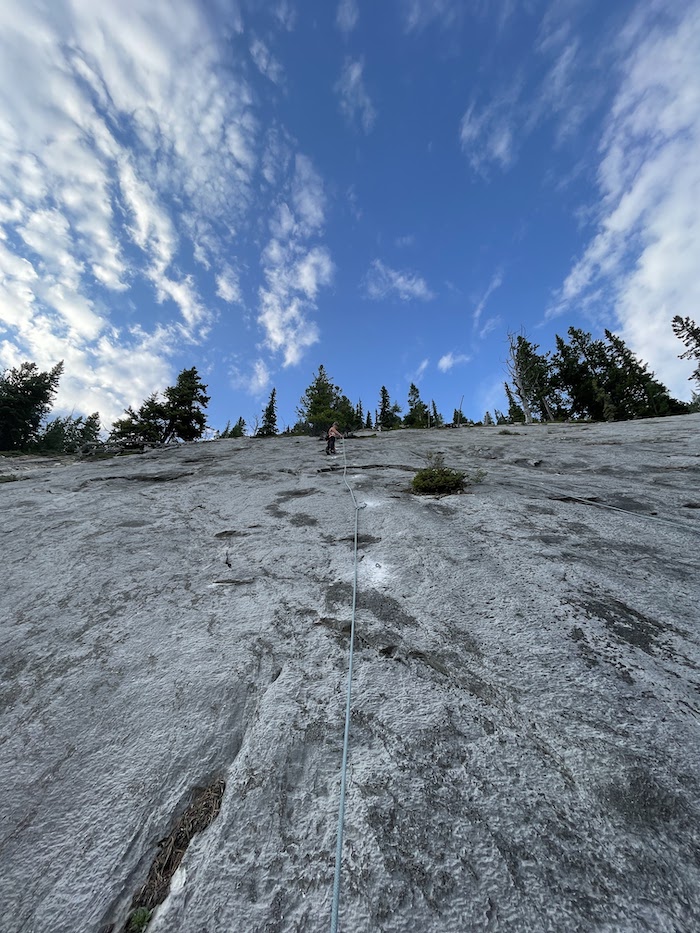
[549, 3, 700, 397]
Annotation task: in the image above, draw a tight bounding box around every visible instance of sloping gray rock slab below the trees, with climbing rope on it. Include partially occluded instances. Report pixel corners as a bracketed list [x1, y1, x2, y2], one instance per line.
[0, 415, 700, 933]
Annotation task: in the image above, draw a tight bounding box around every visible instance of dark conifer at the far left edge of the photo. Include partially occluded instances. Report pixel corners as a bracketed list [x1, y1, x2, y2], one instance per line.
[0, 362, 63, 450]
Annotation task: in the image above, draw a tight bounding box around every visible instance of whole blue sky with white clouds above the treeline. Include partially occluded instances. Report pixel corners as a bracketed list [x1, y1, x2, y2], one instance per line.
[0, 0, 700, 428]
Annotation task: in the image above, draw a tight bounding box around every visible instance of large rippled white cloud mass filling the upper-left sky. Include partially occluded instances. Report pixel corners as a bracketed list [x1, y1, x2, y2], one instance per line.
[0, 0, 258, 419]
